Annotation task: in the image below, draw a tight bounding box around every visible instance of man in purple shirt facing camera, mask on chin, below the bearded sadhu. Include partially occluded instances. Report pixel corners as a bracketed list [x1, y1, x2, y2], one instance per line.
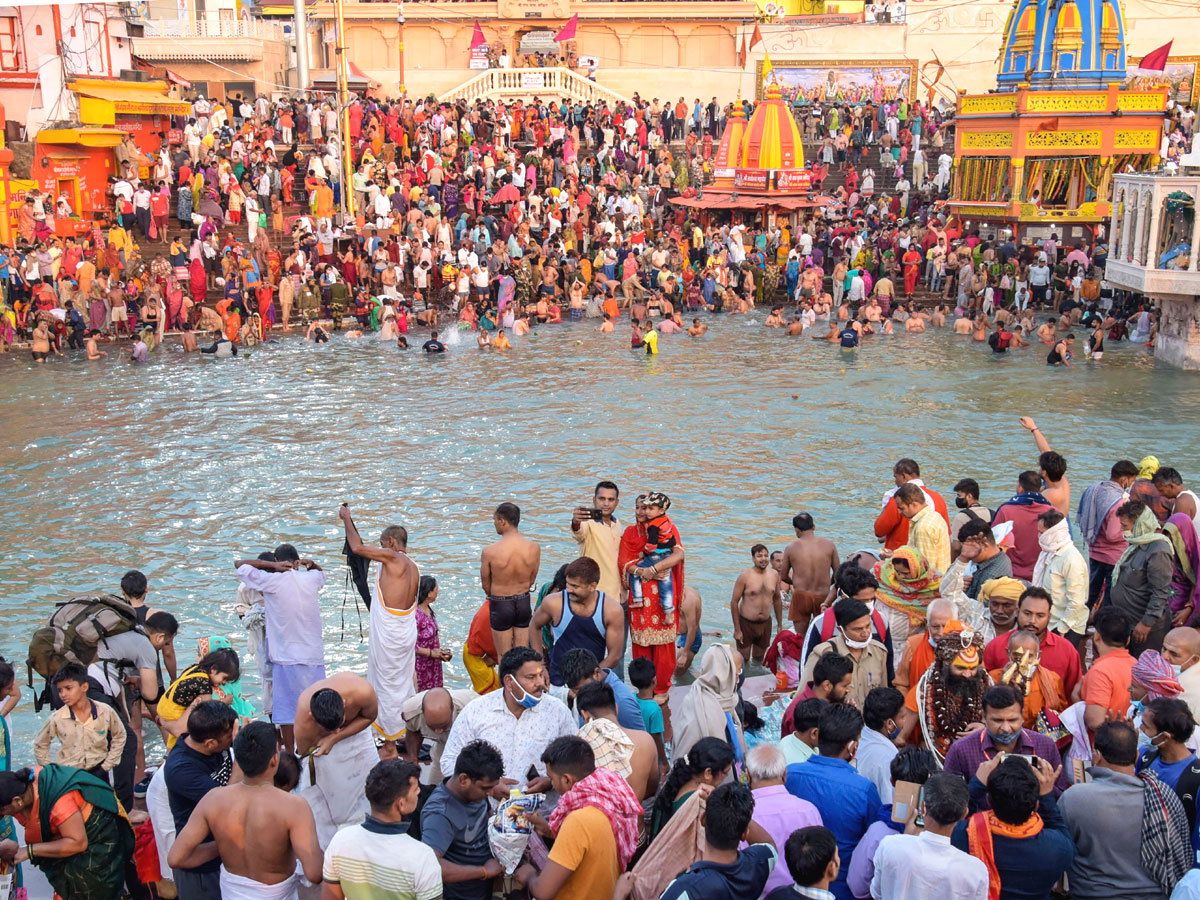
[944, 684, 1070, 812]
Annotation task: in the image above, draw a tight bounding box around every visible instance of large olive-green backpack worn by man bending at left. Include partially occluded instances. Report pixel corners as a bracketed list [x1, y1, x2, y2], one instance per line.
[25, 594, 140, 712]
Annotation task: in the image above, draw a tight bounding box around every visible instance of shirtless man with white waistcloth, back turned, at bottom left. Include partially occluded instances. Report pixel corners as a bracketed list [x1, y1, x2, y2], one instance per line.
[167, 722, 323, 900]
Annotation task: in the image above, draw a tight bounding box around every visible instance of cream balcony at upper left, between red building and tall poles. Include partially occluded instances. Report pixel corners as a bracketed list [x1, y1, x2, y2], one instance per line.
[133, 18, 292, 62]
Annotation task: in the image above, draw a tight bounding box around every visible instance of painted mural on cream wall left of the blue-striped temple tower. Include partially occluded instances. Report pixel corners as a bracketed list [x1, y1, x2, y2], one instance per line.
[758, 60, 917, 106]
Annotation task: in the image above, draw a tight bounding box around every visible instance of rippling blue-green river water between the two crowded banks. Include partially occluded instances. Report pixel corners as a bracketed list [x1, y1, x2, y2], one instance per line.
[0, 313, 1200, 748]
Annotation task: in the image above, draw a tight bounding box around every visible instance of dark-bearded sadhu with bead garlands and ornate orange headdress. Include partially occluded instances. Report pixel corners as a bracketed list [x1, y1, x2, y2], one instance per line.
[901, 631, 991, 763]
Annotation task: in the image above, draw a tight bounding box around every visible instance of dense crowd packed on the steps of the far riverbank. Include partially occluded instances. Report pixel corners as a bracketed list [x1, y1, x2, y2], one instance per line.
[0, 84, 1176, 362]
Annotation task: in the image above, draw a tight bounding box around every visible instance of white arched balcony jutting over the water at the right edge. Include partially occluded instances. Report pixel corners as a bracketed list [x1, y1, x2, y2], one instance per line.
[1105, 175, 1200, 296]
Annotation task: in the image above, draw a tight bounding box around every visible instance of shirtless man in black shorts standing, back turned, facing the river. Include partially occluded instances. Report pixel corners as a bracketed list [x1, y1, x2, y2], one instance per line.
[479, 503, 541, 659]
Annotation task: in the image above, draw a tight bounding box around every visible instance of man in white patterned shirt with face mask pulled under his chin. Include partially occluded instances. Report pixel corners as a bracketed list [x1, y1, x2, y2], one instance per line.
[442, 647, 578, 799]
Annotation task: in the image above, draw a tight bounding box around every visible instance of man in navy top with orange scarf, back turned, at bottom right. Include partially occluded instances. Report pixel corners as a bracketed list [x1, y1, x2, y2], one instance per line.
[950, 754, 1075, 900]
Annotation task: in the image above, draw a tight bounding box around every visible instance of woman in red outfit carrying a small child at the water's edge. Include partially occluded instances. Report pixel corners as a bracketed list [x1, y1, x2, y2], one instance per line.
[617, 494, 684, 700]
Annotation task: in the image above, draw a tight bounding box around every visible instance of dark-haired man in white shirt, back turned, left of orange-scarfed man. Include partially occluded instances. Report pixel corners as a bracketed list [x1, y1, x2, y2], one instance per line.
[871, 773, 988, 900]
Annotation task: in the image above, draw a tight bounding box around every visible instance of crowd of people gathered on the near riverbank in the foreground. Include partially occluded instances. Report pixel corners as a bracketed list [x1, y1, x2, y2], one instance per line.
[7, 418, 1200, 900]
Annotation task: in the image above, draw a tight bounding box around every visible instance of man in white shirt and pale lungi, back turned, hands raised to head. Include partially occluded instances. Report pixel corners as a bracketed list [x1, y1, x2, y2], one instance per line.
[234, 544, 325, 750]
